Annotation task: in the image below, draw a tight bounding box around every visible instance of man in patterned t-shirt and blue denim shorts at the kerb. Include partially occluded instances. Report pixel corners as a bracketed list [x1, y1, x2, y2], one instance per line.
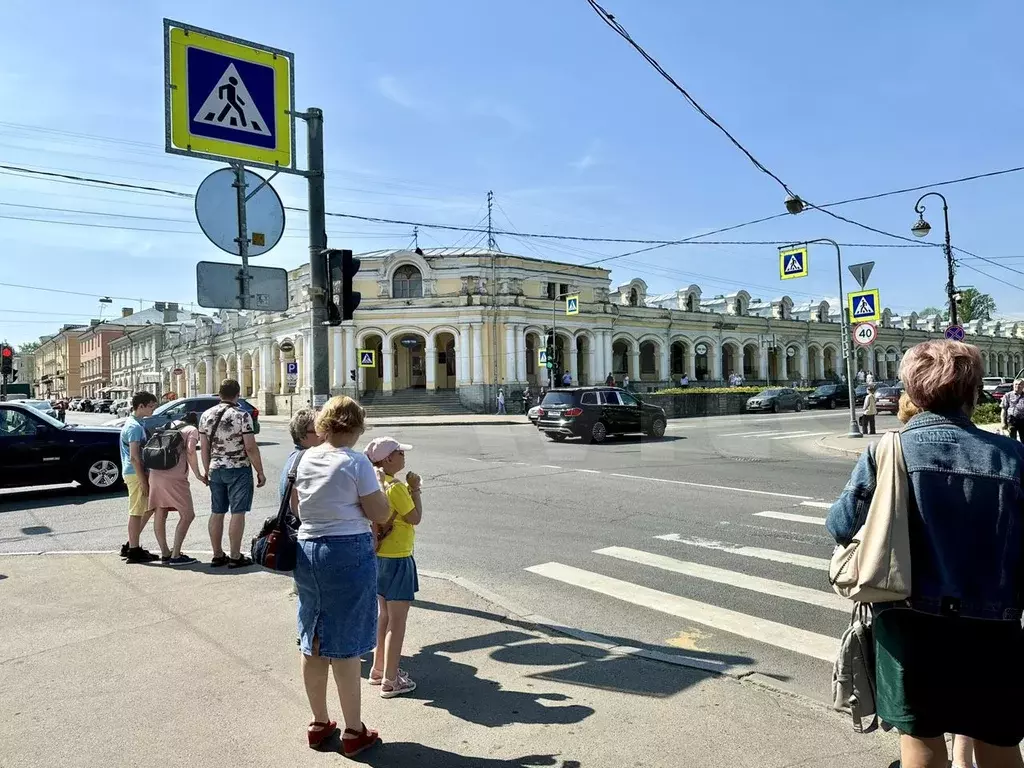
[199, 379, 266, 568]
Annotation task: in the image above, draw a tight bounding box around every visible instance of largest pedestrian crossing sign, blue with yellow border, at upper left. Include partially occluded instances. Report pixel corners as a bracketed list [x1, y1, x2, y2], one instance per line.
[164, 18, 295, 170]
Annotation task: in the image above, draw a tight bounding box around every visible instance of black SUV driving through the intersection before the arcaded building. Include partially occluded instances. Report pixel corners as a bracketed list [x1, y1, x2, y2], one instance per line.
[537, 387, 668, 442]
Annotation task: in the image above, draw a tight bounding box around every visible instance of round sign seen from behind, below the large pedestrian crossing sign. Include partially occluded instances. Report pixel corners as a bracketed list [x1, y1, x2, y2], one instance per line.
[196, 168, 285, 256]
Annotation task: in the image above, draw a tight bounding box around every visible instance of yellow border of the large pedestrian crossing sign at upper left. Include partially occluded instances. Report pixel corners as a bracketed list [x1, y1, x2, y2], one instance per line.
[169, 27, 292, 166]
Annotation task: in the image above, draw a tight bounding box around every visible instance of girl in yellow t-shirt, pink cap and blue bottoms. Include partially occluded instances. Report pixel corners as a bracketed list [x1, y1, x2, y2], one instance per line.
[367, 437, 423, 698]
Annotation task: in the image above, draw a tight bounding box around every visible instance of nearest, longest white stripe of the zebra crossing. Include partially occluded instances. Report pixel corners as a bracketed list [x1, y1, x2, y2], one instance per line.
[526, 562, 839, 664]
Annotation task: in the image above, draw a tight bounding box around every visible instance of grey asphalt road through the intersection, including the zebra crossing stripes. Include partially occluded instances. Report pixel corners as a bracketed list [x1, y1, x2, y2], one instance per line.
[0, 411, 895, 700]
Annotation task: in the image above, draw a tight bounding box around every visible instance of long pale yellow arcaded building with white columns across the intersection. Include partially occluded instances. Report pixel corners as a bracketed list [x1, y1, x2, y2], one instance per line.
[151, 249, 1024, 413]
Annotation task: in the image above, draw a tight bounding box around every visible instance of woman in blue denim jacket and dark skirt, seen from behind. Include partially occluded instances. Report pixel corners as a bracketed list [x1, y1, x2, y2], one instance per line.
[825, 341, 1024, 768]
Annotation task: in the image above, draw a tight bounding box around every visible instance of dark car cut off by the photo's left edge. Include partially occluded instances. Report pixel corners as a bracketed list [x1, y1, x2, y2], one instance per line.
[0, 402, 122, 492]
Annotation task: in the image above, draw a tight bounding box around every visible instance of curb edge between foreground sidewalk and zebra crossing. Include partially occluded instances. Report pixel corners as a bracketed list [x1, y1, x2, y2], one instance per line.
[419, 569, 849, 719]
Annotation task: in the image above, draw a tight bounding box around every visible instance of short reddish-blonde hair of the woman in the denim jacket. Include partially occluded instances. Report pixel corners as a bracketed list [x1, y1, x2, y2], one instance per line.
[899, 341, 983, 412]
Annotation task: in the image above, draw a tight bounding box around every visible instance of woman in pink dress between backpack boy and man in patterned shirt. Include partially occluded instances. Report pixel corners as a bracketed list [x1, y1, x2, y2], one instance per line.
[150, 413, 209, 565]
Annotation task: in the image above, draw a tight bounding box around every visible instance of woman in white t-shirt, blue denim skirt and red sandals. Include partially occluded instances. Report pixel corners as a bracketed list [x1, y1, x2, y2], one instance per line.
[292, 396, 390, 757]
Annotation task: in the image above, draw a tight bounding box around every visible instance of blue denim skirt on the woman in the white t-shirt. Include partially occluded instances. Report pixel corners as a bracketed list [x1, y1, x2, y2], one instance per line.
[295, 534, 377, 658]
